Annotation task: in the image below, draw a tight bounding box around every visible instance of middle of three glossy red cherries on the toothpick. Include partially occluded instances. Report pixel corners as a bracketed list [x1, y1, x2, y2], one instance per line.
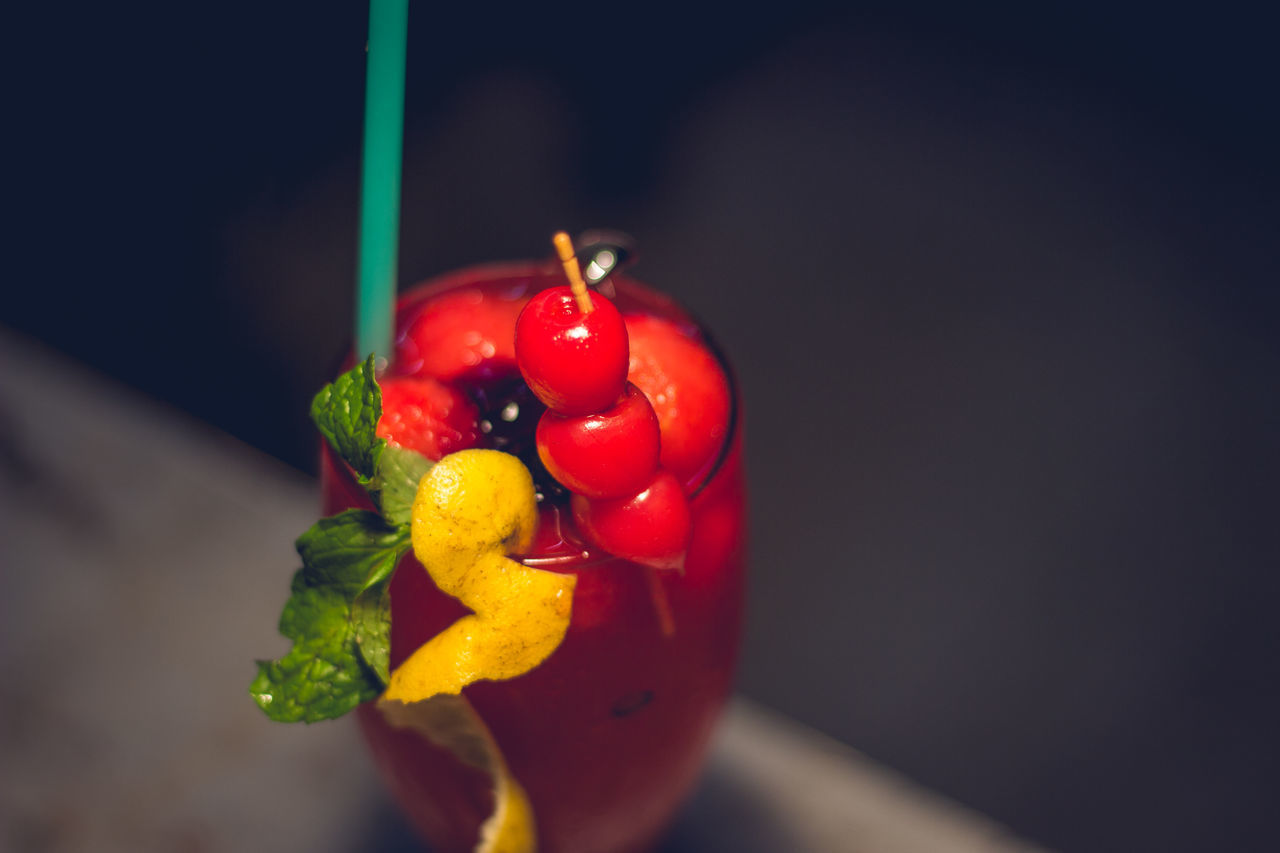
[538, 383, 658, 498]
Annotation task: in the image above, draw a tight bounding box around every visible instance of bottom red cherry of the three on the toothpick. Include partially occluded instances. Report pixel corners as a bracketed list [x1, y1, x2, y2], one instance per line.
[570, 470, 692, 569]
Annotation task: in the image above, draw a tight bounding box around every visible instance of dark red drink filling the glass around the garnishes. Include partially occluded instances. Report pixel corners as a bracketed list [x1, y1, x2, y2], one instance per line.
[321, 264, 745, 853]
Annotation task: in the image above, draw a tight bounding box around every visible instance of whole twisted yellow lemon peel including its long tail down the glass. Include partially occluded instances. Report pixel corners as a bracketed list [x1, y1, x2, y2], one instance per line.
[378, 450, 577, 853]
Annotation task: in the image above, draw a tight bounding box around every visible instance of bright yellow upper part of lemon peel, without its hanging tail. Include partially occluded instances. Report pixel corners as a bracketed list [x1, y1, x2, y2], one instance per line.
[383, 450, 577, 702]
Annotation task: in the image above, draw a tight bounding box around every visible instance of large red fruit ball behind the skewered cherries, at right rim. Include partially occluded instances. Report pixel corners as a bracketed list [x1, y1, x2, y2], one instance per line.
[627, 316, 730, 487]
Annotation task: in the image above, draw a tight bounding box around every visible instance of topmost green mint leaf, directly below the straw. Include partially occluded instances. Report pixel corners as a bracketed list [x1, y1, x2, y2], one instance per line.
[311, 353, 387, 485]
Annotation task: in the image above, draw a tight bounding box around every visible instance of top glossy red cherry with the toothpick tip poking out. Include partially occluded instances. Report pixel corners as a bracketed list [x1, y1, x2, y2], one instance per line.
[516, 286, 627, 415]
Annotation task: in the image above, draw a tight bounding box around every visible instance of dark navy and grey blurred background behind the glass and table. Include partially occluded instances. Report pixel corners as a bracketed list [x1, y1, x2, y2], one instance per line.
[0, 1, 1280, 850]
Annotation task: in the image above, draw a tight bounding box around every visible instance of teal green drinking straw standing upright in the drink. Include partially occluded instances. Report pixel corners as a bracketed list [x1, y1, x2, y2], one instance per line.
[356, 0, 408, 357]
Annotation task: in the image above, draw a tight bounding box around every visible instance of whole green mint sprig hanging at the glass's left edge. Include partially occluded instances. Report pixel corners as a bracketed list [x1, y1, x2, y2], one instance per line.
[250, 355, 431, 722]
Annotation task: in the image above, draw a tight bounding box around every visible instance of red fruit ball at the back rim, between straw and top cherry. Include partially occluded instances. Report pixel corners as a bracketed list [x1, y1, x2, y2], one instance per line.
[396, 287, 527, 382]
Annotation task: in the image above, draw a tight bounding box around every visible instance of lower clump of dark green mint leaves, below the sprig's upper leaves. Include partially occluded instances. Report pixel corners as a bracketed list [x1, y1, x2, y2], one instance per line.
[250, 510, 410, 722]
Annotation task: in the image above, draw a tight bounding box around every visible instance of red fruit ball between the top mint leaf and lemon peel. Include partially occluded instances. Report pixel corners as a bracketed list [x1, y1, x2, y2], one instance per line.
[378, 377, 481, 460]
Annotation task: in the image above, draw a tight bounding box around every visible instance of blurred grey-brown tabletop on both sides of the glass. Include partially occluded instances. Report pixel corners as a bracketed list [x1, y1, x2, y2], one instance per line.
[0, 329, 1036, 853]
